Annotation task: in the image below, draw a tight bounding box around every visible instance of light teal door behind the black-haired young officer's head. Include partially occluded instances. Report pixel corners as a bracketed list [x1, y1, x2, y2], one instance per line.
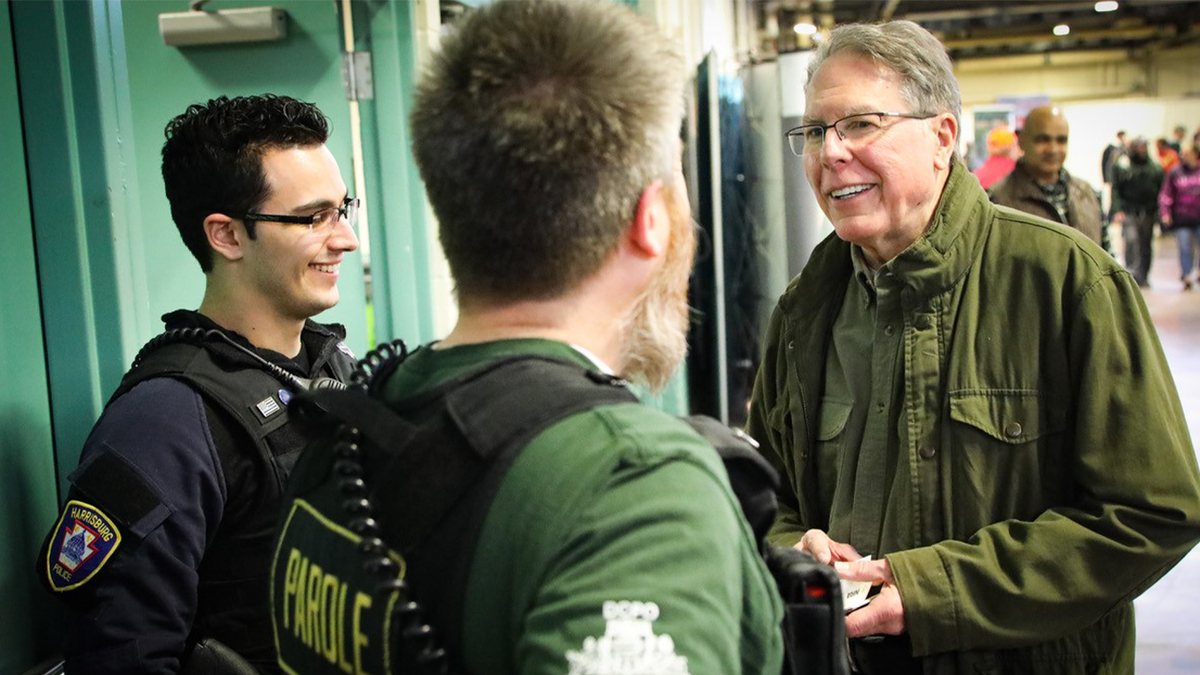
[121, 0, 367, 354]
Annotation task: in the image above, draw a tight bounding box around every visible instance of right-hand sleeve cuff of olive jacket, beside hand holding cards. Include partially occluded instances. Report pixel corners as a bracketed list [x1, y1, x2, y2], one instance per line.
[884, 546, 960, 656]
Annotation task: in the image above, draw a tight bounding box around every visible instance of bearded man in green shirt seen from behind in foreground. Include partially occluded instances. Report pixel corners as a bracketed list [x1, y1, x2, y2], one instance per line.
[271, 0, 782, 675]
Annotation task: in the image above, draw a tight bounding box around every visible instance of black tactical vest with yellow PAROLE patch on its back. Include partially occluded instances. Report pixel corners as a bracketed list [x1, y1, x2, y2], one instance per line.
[270, 354, 806, 675]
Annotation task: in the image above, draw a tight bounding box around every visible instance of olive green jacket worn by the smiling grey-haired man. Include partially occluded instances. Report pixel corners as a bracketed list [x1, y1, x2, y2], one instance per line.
[749, 166, 1200, 674]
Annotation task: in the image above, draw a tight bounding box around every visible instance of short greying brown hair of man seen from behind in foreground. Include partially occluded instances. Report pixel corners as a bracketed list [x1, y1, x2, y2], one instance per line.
[412, 0, 684, 304]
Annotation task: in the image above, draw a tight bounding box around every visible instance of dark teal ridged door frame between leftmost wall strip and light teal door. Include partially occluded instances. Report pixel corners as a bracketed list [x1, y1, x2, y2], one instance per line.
[11, 1, 134, 487]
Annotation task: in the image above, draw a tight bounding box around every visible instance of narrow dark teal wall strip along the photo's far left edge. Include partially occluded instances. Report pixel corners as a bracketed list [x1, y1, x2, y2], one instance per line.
[0, 0, 58, 674]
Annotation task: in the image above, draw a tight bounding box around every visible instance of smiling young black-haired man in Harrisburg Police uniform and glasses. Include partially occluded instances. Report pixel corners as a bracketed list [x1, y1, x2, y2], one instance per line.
[37, 95, 358, 675]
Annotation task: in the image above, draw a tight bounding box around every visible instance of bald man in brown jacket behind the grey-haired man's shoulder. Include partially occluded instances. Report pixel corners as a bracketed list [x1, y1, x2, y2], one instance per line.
[988, 106, 1109, 250]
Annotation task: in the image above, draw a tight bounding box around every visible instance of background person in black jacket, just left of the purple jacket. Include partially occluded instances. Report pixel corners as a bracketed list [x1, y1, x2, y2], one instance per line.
[1112, 136, 1163, 288]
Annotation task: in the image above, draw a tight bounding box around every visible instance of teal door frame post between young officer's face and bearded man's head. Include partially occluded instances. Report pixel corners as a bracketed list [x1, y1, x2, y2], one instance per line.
[353, 0, 441, 345]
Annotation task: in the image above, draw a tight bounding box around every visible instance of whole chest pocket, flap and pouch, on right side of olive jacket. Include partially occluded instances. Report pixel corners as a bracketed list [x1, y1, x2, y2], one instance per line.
[946, 389, 1066, 537]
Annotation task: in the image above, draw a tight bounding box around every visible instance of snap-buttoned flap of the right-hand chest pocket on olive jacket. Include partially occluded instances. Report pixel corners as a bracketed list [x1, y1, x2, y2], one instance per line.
[950, 389, 1067, 444]
